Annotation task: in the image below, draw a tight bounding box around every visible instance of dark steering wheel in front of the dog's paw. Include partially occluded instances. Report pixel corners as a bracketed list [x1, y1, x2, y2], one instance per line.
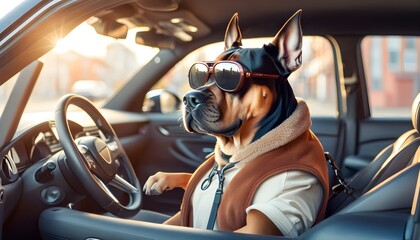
[55, 94, 142, 217]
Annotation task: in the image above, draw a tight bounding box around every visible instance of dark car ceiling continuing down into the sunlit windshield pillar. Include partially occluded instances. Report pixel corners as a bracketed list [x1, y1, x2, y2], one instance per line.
[0, 0, 420, 86]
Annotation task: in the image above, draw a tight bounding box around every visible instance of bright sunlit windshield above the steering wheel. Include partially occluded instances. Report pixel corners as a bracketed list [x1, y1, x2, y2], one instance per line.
[0, 23, 159, 112]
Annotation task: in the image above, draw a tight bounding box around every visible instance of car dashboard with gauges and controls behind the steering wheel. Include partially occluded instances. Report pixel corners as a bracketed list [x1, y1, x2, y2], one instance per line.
[0, 109, 149, 234]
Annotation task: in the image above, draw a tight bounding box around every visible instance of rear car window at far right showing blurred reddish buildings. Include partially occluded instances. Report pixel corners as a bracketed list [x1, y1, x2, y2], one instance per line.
[361, 36, 420, 117]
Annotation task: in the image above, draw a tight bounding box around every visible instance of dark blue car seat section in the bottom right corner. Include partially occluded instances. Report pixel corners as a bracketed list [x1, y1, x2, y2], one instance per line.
[299, 147, 420, 240]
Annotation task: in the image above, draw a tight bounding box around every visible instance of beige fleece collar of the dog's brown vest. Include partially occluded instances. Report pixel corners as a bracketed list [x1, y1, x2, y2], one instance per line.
[215, 98, 312, 168]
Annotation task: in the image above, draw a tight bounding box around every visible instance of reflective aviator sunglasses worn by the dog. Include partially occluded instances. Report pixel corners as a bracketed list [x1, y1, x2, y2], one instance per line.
[188, 61, 280, 92]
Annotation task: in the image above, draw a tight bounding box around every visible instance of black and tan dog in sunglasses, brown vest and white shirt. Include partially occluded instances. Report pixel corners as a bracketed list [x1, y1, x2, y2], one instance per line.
[144, 10, 328, 237]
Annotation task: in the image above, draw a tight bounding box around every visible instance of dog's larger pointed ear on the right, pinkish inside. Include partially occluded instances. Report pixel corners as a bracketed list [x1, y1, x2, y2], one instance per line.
[271, 10, 302, 73]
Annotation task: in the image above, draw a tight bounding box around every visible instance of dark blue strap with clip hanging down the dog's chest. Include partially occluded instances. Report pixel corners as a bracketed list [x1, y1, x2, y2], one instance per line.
[206, 163, 236, 230]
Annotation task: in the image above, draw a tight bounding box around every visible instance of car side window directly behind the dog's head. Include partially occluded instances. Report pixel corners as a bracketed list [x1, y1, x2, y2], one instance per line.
[153, 36, 338, 117]
